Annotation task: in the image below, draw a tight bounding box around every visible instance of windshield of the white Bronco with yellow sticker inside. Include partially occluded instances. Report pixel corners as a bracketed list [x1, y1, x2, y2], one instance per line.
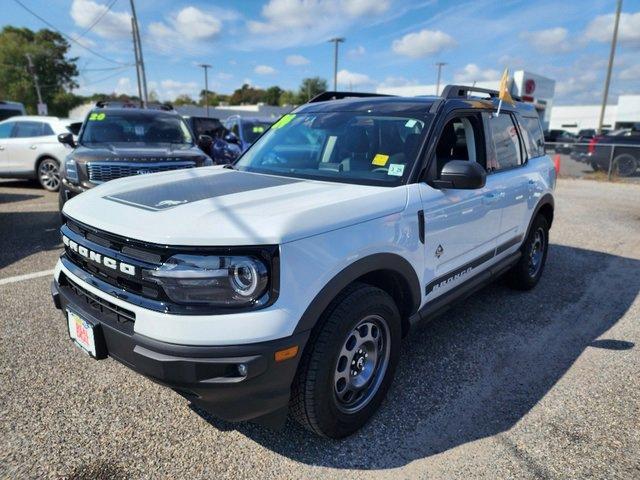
[235, 112, 425, 186]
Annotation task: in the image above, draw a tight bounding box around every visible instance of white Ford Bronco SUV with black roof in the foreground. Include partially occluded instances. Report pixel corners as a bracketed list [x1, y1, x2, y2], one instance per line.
[52, 86, 556, 438]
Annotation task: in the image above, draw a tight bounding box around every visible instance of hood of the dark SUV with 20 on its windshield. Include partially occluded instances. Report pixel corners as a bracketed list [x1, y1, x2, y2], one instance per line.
[73, 145, 203, 162]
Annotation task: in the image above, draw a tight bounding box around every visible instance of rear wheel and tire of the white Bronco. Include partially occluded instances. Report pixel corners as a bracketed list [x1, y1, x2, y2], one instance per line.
[507, 215, 549, 290]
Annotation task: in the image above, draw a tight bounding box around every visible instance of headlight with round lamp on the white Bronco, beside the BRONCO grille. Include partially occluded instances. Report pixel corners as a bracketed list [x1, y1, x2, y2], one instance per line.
[143, 254, 269, 307]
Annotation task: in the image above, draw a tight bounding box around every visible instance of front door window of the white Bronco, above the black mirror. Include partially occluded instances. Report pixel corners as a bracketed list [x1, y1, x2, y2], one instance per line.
[435, 115, 485, 175]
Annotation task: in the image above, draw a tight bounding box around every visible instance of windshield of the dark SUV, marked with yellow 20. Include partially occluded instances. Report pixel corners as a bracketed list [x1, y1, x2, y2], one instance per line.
[80, 110, 193, 146]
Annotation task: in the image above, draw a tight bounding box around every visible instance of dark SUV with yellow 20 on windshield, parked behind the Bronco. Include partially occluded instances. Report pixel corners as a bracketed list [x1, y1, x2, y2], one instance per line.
[58, 102, 213, 209]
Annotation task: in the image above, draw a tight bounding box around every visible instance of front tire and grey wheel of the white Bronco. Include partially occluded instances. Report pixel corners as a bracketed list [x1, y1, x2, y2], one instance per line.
[290, 283, 401, 438]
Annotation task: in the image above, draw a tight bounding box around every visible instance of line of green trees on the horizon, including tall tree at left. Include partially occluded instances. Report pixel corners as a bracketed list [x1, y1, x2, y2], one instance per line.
[0, 26, 327, 116]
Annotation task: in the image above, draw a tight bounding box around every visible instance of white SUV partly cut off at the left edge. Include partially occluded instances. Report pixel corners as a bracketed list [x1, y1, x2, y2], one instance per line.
[0, 116, 71, 192]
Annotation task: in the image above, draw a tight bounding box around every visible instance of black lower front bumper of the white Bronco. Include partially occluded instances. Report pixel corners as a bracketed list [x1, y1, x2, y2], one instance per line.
[51, 281, 309, 425]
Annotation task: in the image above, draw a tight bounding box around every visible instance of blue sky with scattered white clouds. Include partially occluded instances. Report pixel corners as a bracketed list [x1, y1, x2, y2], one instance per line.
[2, 0, 640, 104]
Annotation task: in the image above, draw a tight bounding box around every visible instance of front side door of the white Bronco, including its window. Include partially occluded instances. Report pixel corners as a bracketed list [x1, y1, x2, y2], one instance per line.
[420, 112, 504, 301]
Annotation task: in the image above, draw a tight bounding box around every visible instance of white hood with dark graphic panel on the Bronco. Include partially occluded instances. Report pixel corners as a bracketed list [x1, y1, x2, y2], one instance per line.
[64, 167, 407, 246]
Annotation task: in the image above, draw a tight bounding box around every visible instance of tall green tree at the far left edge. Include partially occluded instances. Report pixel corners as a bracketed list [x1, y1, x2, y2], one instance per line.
[0, 26, 81, 115]
